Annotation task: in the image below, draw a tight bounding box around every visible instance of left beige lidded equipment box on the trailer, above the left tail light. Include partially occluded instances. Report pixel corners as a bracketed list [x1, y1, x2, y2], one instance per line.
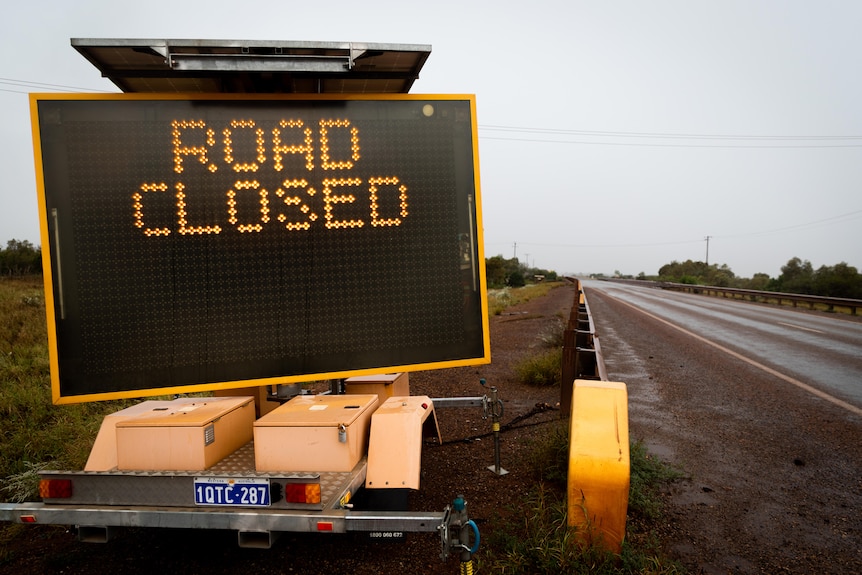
[116, 397, 254, 471]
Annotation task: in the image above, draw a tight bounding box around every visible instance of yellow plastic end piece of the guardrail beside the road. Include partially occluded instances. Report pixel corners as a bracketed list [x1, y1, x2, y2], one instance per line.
[568, 379, 630, 553]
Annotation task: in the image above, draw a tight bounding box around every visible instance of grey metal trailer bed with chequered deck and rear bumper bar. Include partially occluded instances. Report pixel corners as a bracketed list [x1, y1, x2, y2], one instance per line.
[0, 442, 449, 548]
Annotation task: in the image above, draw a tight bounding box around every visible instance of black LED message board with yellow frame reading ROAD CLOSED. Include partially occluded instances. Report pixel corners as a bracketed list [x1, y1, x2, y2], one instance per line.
[31, 95, 490, 403]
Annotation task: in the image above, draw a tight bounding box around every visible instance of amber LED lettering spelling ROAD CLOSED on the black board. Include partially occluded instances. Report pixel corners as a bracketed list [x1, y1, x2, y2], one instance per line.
[141, 117, 409, 237]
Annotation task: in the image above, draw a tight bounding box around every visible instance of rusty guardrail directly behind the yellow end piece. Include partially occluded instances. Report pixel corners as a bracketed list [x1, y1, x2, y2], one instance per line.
[560, 278, 608, 413]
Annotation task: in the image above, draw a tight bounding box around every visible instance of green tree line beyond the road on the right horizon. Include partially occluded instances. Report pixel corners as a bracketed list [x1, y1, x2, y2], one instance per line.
[656, 257, 862, 299]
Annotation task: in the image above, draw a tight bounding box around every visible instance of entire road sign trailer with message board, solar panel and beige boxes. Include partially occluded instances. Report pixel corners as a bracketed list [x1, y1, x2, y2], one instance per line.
[0, 39, 490, 562]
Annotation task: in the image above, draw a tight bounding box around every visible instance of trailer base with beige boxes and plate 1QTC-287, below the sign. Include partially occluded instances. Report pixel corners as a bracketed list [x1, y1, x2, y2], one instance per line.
[10, 388, 479, 559]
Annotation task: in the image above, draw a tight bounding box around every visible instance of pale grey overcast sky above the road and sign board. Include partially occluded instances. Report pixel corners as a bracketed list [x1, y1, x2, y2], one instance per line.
[0, 0, 862, 277]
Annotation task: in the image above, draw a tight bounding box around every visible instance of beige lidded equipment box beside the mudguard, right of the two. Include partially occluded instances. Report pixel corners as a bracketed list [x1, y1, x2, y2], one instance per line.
[254, 395, 379, 472]
